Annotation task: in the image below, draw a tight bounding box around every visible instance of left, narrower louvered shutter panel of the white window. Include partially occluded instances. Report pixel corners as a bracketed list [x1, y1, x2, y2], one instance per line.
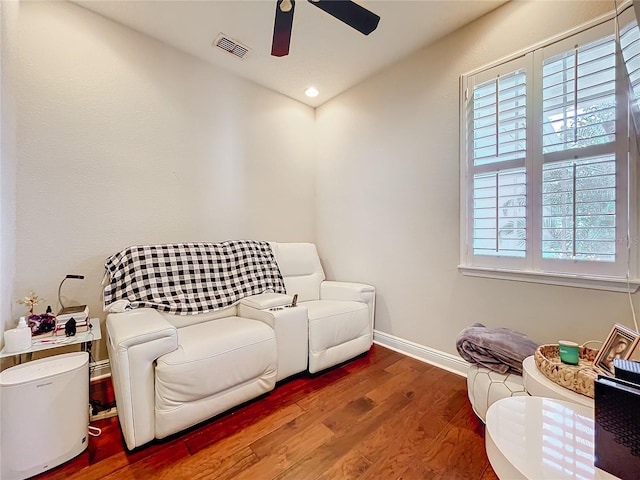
[468, 60, 528, 259]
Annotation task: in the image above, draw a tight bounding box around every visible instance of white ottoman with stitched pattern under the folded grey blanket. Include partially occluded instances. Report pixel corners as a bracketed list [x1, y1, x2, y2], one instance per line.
[467, 365, 529, 422]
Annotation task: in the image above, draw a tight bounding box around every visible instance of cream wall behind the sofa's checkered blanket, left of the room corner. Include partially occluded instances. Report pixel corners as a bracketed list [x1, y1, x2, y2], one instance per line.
[13, 2, 314, 358]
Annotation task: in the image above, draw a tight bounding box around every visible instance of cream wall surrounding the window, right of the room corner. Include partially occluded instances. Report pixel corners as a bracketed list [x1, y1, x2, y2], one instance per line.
[316, 1, 639, 353]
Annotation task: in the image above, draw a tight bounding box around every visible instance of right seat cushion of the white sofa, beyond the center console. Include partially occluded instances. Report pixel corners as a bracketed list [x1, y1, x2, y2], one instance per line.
[300, 300, 371, 352]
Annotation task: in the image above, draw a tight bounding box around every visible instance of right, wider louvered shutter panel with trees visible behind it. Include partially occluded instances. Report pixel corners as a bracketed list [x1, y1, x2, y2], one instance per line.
[541, 34, 616, 262]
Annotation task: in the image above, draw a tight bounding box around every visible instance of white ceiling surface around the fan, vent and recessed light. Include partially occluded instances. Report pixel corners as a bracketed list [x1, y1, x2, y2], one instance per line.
[75, 0, 507, 107]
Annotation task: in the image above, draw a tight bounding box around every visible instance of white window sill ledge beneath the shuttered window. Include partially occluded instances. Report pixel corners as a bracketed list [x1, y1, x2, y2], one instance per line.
[458, 265, 640, 293]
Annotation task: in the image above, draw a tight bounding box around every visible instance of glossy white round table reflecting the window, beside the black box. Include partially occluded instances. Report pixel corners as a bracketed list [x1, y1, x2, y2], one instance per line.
[485, 397, 617, 480]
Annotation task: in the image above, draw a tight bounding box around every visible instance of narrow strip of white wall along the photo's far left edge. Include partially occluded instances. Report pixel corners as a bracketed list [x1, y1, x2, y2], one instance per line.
[0, 2, 20, 345]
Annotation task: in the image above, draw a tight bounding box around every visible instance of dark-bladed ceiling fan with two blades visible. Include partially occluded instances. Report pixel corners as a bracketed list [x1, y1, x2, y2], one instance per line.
[271, 0, 380, 57]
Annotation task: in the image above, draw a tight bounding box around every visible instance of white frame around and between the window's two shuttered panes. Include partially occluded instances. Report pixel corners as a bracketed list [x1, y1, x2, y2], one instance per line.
[458, 15, 640, 292]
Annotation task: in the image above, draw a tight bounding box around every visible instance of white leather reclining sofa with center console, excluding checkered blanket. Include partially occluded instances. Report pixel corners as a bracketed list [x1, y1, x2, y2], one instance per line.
[106, 243, 375, 449]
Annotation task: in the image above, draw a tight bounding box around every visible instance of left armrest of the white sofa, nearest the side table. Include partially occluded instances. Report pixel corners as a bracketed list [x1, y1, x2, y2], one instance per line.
[106, 308, 178, 449]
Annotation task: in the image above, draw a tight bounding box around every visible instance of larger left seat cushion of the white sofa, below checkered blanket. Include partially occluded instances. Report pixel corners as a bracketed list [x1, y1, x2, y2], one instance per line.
[155, 317, 277, 410]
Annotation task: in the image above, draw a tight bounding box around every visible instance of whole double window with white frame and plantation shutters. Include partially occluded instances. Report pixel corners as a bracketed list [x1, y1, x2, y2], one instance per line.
[461, 17, 640, 288]
